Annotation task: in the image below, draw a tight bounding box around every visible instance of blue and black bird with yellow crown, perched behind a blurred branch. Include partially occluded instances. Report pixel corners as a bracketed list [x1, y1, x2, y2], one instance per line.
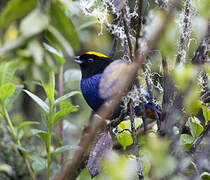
[74, 51, 160, 119]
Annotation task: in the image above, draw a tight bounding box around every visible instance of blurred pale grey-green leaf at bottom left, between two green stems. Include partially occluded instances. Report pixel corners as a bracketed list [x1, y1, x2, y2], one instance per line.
[29, 154, 47, 173]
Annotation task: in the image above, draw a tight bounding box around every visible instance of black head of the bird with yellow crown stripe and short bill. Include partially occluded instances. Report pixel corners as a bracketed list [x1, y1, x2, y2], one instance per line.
[74, 51, 113, 78]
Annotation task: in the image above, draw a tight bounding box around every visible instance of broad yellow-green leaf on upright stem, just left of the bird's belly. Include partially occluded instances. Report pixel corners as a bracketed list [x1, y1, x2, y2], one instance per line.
[50, 102, 78, 126]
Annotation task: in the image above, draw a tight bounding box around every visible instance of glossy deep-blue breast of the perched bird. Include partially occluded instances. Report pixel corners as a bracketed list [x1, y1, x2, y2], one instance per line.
[81, 74, 105, 112]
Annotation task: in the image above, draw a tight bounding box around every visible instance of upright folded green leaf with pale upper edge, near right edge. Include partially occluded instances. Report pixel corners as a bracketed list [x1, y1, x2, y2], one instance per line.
[188, 117, 204, 138]
